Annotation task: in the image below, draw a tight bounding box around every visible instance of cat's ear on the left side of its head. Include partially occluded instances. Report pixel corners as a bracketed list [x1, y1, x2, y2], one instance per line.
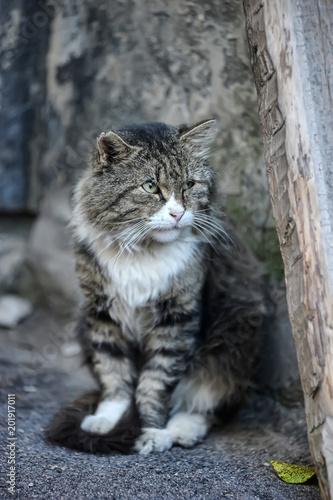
[96, 132, 141, 167]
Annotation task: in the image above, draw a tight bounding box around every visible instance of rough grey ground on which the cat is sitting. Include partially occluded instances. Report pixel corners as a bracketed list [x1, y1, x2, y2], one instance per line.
[0, 310, 320, 500]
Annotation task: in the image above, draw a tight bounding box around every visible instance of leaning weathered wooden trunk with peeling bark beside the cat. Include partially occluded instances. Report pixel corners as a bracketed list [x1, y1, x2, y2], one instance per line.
[244, 0, 333, 499]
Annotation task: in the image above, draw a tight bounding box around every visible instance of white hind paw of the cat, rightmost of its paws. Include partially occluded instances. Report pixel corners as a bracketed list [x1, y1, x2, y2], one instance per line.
[167, 412, 209, 448]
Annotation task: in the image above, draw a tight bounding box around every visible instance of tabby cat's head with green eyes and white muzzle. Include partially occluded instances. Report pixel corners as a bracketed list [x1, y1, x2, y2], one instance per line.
[75, 120, 215, 248]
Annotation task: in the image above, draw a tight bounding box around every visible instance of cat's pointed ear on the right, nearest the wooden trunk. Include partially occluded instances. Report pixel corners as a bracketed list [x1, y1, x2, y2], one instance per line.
[178, 119, 216, 158]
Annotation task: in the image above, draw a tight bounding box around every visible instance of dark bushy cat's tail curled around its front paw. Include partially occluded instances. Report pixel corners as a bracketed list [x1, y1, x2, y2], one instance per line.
[45, 390, 141, 454]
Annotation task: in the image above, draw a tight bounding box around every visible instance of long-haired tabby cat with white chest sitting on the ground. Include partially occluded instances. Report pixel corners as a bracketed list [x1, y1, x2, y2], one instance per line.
[48, 120, 262, 454]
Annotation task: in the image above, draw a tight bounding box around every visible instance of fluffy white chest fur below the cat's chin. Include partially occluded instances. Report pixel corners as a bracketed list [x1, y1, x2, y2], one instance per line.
[93, 238, 197, 310]
